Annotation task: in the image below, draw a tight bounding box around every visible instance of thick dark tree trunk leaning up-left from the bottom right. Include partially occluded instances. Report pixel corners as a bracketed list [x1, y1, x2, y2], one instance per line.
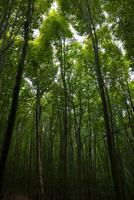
[82, 0, 129, 200]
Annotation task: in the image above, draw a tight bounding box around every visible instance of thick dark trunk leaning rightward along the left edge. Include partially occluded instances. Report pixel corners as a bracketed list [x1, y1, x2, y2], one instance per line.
[0, 0, 34, 192]
